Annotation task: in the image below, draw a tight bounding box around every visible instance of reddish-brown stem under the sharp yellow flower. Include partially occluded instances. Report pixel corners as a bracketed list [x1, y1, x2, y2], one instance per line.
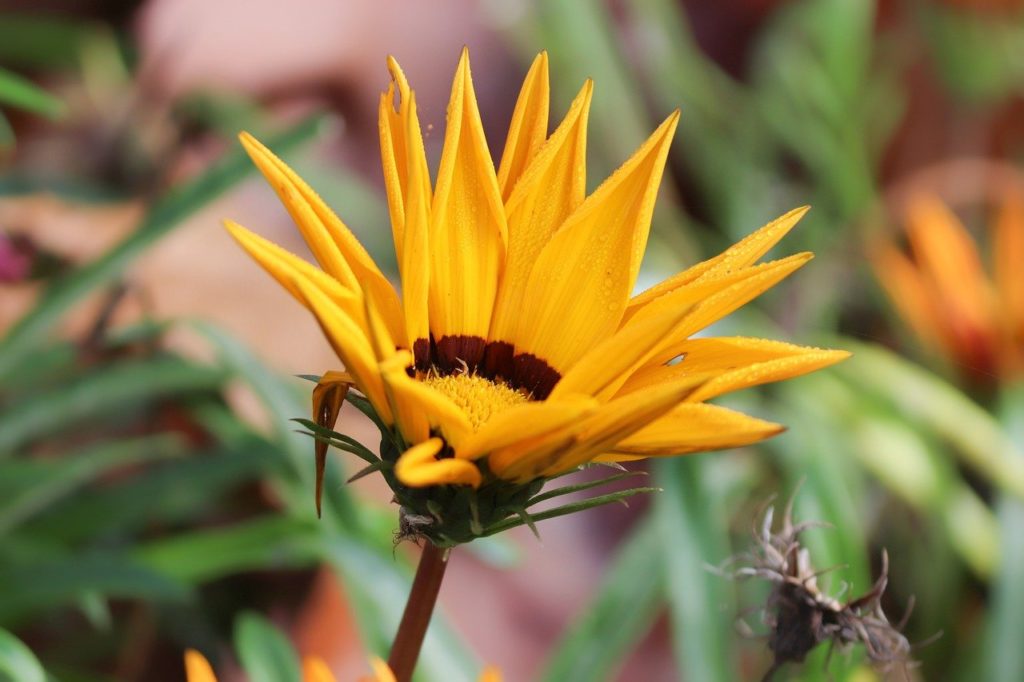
[387, 541, 449, 682]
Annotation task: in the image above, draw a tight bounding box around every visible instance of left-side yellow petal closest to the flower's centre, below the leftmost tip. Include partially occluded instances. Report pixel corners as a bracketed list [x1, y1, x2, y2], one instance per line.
[295, 280, 394, 424]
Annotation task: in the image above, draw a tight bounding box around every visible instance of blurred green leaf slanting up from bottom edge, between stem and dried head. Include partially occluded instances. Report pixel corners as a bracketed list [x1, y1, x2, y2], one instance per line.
[539, 518, 665, 682]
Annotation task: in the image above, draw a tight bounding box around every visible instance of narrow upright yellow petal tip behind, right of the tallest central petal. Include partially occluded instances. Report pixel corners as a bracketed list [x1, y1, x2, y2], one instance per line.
[498, 52, 550, 201]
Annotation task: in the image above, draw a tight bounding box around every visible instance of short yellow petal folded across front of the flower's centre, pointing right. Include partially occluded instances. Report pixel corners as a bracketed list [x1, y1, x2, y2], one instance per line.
[455, 396, 597, 460]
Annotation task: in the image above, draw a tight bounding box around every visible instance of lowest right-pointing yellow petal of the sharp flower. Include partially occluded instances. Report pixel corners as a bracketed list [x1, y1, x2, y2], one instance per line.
[614, 403, 784, 456]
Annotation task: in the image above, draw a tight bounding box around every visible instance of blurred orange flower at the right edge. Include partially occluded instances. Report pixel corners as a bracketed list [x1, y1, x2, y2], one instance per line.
[871, 195, 1024, 384]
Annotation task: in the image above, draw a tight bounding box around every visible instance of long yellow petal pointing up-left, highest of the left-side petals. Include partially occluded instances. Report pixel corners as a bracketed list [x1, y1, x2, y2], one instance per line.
[239, 132, 404, 338]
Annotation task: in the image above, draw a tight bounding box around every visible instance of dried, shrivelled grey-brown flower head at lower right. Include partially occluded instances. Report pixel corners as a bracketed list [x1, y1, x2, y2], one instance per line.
[730, 493, 914, 682]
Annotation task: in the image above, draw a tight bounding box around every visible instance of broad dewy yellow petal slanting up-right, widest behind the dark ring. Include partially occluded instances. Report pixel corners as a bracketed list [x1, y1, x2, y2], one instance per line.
[515, 112, 679, 372]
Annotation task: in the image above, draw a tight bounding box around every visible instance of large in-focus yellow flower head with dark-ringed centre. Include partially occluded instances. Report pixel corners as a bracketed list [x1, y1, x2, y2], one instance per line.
[227, 51, 847, 532]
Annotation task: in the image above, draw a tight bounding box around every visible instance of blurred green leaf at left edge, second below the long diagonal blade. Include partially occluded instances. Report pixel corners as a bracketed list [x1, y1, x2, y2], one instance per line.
[0, 435, 184, 536]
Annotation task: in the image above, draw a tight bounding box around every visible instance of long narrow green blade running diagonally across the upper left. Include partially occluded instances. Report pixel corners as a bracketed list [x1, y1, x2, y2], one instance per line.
[0, 117, 321, 380]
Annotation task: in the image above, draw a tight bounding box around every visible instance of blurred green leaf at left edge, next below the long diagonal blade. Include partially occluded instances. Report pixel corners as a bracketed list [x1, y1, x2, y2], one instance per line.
[0, 351, 225, 450]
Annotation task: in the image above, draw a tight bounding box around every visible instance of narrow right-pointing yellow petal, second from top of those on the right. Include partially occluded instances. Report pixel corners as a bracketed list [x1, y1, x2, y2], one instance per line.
[650, 253, 813, 365]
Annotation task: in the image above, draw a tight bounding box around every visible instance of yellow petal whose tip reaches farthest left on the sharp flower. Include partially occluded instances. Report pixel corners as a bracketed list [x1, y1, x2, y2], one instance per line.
[224, 220, 362, 319]
